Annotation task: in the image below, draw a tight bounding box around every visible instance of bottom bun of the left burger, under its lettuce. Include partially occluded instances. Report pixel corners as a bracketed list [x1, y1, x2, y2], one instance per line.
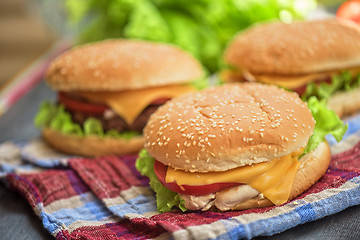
[42, 127, 144, 157]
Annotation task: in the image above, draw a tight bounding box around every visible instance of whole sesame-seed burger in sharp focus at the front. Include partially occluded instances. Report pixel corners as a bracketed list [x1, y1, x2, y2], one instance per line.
[136, 83, 346, 211]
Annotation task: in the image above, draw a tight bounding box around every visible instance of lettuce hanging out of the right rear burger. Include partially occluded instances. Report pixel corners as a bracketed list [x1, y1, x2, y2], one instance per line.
[301, 71, 360, 101]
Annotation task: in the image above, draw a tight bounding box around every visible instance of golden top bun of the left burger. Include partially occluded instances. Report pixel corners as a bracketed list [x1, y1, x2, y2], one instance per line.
[46, 39, 204, 91]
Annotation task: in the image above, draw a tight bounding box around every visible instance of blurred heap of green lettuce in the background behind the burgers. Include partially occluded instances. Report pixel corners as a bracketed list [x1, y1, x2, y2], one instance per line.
[65, 0, 316, 72]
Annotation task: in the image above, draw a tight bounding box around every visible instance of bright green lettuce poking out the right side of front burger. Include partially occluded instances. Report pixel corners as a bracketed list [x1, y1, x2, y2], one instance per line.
[303, 96, 348, 154]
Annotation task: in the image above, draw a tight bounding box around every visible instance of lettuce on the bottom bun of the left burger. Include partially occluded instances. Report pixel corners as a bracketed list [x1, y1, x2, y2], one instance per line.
[34, 102, 141, 140]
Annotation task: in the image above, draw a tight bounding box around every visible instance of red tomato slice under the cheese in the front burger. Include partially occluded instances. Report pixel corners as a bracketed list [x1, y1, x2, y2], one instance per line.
[154, 160, 242, 195]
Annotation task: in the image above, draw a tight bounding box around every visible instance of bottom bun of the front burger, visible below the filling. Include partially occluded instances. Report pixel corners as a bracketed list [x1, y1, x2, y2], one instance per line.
[231, 142, 331, 210]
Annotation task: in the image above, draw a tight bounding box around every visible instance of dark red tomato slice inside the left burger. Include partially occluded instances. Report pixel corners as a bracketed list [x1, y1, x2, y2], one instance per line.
[58, 93, 108, 114]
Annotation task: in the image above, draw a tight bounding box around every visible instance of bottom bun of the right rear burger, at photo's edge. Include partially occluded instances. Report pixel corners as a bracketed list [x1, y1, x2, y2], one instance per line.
[328, 87, 360, 117]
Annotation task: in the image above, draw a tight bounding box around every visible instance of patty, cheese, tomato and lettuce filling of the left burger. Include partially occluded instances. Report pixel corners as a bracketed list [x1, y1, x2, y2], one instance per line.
[35, 84, 195, 139]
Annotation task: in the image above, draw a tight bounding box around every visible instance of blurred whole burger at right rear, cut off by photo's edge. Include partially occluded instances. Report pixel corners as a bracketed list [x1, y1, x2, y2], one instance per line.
[221, 18, 360, 116]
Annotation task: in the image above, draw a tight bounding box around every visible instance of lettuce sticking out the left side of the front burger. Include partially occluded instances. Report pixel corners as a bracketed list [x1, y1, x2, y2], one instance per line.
[135, 149, 187, 212]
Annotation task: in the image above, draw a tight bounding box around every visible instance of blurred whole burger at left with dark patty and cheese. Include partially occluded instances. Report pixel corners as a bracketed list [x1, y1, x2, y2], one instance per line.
[35, 39, 205, 156]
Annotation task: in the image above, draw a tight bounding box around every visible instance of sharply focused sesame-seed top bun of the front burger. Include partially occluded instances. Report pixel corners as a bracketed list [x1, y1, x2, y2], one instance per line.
[144, 83, 315, 172]
